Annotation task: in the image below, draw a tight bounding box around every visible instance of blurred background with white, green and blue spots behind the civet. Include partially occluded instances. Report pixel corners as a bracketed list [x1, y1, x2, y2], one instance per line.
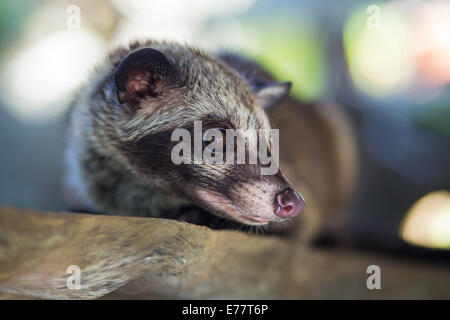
[0, 0, 450, 257]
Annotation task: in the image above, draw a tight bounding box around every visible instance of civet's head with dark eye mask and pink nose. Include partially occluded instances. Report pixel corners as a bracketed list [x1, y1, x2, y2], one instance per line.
[94, 43, 305, 225]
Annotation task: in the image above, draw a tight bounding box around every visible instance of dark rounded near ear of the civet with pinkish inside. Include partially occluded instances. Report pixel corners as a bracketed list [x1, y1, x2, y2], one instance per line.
[114, 48, 176, 110]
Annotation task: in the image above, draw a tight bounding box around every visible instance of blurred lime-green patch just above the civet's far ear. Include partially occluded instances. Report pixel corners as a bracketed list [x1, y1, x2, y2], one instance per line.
[246, 18, 327, 101]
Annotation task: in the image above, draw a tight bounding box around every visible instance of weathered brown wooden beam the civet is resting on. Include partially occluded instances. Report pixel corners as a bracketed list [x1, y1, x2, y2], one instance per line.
[0, 208, 450, 299]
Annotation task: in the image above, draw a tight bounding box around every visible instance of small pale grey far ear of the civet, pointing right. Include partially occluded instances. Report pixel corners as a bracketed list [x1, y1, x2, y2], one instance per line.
[255, 82, 292, 110]
